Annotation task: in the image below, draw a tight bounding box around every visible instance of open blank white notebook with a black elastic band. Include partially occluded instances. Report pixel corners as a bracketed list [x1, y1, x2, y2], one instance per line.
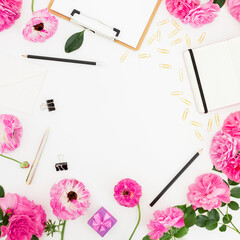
[184, 37, 240, 113]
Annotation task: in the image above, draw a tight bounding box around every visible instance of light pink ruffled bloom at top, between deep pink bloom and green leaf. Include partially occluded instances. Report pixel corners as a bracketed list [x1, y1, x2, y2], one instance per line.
[182, 0, 220, 28]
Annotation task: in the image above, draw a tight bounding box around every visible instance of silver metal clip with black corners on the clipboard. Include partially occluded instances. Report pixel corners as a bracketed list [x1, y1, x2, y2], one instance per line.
[70, 9, 120, 41]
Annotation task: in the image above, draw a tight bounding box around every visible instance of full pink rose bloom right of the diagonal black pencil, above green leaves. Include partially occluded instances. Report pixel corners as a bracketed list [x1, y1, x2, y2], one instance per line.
[187, 173, 230, 211]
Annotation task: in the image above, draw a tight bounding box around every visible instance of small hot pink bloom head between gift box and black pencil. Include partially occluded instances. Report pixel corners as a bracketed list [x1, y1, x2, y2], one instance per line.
[114, 178, 142, 207]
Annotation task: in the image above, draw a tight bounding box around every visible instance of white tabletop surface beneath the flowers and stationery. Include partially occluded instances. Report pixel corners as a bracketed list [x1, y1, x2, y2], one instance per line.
[0, 0, 240, 240]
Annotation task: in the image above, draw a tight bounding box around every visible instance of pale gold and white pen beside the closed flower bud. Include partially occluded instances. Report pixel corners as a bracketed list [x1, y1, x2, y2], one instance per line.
[26, 128, 49, 185]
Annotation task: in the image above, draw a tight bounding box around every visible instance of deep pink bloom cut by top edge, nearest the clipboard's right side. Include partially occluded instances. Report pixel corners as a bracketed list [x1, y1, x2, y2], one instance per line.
[166, 0, 200, 20]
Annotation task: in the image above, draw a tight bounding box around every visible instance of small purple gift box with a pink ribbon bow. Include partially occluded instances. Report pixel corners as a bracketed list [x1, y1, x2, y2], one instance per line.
[88, 207, 117, 237]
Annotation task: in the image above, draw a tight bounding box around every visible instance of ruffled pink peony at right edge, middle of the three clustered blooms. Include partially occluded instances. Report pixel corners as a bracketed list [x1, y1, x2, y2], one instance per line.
[210, 131, 240, 171]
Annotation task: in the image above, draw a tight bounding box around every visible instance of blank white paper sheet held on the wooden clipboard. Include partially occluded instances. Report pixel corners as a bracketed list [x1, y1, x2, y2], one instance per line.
[51, 0, 157, 47]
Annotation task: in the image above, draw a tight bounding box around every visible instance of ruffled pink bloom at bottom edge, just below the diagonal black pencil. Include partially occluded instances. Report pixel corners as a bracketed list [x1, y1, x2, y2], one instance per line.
[148, 207, 184, 240]
